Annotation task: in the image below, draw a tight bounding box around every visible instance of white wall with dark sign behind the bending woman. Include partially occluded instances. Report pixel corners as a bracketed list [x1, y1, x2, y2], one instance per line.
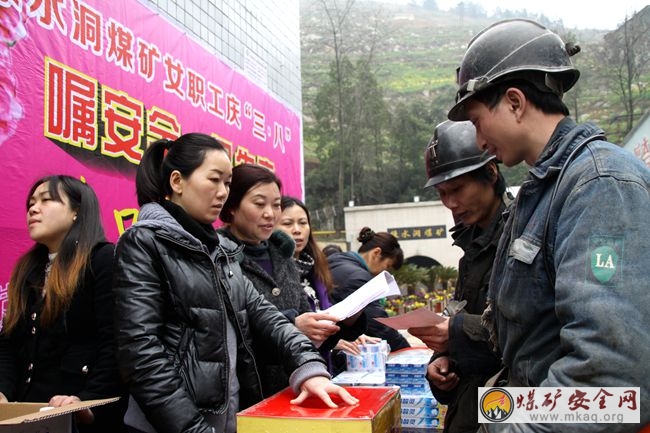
[344, 201, 463, 268]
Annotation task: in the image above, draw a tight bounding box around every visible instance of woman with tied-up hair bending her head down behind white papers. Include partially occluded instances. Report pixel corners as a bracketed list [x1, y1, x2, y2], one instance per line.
[327, 227, 410, 364]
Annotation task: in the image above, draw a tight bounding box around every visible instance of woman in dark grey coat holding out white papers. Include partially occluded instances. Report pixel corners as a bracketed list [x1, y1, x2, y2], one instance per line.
[219, 164, 360, 397]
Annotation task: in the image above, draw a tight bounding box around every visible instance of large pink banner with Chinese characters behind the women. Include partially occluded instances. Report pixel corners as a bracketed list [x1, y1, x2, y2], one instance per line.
[0, 0, 302, 310]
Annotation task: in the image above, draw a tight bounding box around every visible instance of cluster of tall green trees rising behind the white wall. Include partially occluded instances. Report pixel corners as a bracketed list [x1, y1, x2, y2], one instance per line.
[305, 56, 390, 214]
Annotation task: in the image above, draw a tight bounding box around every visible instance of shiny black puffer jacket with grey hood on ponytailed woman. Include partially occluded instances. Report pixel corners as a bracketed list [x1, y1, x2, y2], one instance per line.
[113, 203, 323, 433]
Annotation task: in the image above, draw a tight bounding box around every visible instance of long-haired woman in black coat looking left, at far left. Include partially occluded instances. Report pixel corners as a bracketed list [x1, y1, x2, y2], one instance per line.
[0, 175, 125, 432]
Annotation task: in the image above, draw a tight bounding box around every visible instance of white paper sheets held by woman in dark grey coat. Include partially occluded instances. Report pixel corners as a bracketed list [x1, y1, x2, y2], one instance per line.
[324, 271, 402, 320]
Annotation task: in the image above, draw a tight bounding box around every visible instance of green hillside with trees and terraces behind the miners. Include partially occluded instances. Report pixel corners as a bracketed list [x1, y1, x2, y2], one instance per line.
[300, 0, 650, 229]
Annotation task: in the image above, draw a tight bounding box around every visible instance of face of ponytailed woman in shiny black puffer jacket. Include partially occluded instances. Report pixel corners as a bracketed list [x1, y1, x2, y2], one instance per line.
[170, 150, 232, 224]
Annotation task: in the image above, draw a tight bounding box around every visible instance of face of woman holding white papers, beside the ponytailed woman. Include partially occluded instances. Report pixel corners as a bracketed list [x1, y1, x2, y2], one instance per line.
[230, 182, 282, 245]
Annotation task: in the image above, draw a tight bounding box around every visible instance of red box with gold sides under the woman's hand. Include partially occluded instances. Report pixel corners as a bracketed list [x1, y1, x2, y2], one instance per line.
[237, 387, 401, 433]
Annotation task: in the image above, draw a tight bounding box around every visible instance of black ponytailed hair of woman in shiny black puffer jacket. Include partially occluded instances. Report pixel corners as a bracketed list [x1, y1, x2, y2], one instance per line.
[135, 132, 227, 206]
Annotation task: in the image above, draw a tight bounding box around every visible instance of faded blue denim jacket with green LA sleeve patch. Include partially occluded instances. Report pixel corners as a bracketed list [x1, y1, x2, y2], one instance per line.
[489, 118, 650, 432]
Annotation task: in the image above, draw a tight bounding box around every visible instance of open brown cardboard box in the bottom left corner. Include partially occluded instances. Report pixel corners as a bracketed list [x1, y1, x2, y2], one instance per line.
[0, 397, 119, 433]
